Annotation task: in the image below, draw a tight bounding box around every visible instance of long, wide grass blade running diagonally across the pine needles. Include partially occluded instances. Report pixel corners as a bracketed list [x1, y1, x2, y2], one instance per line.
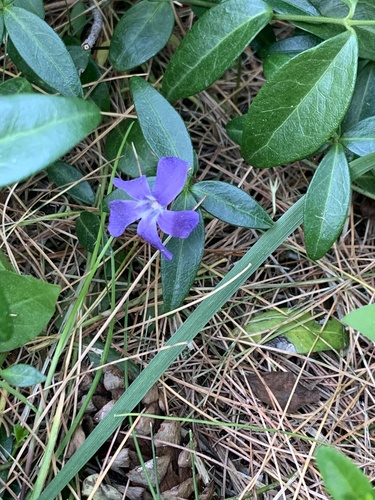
[35, 153, 375, 500]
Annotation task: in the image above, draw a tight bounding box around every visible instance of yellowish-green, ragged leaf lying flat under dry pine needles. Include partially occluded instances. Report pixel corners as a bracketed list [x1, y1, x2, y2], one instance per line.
[245, 309, 349, 354]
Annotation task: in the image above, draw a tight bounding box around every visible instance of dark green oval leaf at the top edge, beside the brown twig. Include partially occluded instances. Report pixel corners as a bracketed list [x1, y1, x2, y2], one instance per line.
[109, 0, 174, 71]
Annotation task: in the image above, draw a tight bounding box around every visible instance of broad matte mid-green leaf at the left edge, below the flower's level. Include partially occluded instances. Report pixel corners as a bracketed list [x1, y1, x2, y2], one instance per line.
[0, 271, 60, 352]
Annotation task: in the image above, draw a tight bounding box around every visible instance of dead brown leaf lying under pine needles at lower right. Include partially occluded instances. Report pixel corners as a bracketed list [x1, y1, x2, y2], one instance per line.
[246, 372, 320, 413]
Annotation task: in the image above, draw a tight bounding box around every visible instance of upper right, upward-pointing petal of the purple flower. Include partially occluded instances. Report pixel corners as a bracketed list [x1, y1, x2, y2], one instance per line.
[152, 156, 189, 207]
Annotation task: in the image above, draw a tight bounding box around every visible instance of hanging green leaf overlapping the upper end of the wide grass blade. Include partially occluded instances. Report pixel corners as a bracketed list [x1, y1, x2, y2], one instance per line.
[303, 144, 350, 260]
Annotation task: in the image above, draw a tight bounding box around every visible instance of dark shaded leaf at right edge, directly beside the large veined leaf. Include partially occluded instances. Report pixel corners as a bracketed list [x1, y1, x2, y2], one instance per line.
[341, 61, 375, 131]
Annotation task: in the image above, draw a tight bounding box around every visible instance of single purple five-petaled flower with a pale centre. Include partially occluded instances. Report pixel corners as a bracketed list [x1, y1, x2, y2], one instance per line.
[108, 157, 199, 260]
